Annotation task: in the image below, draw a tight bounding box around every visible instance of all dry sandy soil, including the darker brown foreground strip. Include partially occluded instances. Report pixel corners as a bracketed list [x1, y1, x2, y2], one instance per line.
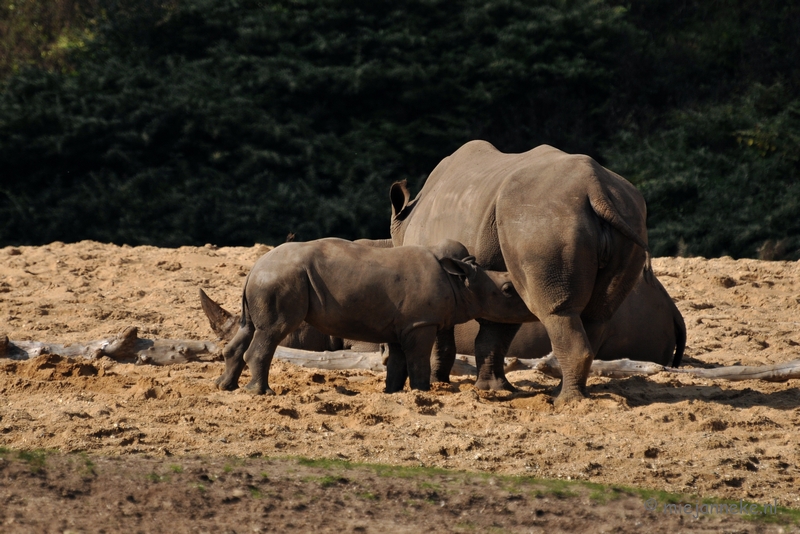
[0, 242, 800, 532]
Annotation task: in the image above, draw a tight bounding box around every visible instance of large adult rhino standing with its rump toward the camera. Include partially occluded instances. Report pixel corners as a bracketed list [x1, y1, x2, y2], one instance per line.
[390, 141, 652, 405]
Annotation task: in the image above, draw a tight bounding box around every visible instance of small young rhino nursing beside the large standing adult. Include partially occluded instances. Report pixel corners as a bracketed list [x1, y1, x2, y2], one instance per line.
[216, 238, 532, 395]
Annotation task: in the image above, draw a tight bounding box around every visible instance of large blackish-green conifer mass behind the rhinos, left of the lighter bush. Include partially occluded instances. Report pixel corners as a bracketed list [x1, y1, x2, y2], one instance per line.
[0, 0, 629, 246]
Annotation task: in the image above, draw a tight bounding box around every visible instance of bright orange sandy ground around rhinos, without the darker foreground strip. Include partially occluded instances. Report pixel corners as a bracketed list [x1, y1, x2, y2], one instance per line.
[0, 242, 800, 531]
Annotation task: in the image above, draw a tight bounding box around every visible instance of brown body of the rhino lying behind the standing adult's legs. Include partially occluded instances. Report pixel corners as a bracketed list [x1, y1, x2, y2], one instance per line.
[455, 277, 686, 367]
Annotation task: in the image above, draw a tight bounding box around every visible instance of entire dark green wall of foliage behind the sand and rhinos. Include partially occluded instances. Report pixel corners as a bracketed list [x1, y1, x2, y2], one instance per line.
[0, 0, 800, 257]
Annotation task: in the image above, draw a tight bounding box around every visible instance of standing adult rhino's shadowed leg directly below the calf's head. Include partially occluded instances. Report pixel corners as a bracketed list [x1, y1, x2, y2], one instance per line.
[475, 319, 520, 391]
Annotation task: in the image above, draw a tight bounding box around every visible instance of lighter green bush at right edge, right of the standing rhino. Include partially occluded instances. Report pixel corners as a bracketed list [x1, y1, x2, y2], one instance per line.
[607, 85, 800, 259]
